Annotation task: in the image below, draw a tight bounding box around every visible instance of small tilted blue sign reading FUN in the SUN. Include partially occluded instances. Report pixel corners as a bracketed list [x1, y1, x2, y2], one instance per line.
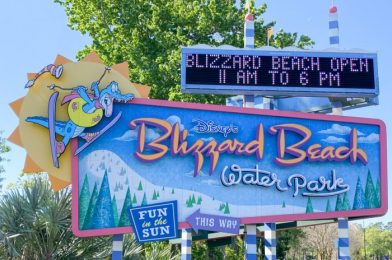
[129, 201, 178, 243]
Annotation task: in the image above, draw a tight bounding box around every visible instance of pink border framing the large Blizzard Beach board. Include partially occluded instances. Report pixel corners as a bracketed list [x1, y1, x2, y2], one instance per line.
[71, 98, 388, 237]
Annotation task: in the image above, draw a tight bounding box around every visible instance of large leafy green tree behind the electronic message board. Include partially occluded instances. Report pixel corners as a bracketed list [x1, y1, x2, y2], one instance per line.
[54, 0, 314, 103]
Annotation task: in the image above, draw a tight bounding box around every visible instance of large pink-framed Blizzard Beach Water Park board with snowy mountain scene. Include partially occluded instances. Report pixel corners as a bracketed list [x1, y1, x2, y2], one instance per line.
[71, 99, 387, 236]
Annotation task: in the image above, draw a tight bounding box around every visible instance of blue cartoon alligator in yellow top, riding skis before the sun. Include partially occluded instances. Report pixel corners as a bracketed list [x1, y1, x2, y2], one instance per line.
[26, 77, 134, 158]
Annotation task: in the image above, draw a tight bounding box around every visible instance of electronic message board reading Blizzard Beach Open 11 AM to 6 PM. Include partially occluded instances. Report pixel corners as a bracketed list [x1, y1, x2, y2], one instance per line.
[181, 45, 378, 97]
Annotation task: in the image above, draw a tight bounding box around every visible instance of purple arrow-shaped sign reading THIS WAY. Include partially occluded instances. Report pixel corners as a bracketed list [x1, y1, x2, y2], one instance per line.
[186, 209, 240, 234]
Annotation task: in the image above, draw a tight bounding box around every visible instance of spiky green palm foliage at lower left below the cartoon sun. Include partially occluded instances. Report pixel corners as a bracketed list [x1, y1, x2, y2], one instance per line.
[0, 177, 111, 259]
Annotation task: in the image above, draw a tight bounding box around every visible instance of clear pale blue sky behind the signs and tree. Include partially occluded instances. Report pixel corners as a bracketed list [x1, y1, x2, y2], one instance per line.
[0, 0, 392, 223]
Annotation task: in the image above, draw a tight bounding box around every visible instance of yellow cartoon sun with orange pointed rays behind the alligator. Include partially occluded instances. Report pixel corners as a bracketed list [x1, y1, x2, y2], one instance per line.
[8, 52, 150, 190]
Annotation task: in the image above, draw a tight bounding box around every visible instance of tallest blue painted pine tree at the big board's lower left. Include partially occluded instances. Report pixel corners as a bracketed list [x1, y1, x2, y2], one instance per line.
[91, 171, 114, 228]
